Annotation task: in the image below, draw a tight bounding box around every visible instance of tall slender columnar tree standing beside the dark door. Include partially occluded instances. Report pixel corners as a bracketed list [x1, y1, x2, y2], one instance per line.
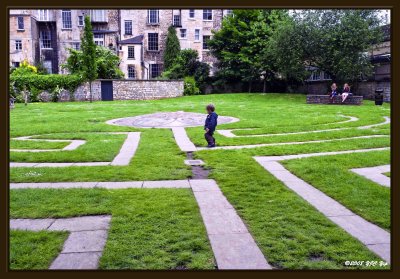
[82, 16, 97, 102]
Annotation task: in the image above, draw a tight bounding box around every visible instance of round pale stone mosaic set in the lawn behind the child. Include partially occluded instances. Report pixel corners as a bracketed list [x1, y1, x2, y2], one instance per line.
[106, 111, 239, 128]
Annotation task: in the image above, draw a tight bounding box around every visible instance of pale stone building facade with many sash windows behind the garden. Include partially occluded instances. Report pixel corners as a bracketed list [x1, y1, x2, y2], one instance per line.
[9, 9, 231, 79]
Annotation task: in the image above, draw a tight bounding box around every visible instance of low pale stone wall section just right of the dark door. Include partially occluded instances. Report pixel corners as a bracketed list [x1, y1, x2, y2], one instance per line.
[113, 80, 183, 100]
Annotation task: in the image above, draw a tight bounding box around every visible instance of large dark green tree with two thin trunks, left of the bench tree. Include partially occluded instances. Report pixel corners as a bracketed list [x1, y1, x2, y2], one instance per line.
[208, 9, 288, 92]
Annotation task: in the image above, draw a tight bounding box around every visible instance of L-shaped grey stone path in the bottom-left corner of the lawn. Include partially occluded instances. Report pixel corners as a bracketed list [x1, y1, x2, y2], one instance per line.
[10, 215, 111, 269]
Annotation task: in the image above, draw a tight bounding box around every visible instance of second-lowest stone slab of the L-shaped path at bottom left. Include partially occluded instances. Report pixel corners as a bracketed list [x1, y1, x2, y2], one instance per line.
[62, 230, 107, 253]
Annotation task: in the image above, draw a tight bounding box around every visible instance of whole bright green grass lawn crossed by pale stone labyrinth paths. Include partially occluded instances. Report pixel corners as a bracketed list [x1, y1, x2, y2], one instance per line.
[10, 94, 390, 269]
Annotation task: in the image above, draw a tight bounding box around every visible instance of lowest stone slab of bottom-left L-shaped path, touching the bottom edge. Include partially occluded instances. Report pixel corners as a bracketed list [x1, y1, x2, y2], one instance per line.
[50, 252, 101, 270]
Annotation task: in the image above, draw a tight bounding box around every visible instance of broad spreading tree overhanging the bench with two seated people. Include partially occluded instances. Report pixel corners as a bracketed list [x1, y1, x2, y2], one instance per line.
[274, 9, 382, 86]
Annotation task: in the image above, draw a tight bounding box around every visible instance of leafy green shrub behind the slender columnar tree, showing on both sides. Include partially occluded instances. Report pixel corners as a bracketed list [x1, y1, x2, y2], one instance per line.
[62, 46, 124, 79]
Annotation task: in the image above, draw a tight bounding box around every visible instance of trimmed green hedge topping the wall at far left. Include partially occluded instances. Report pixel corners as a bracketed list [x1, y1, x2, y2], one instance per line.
[10, 74, 83, 92]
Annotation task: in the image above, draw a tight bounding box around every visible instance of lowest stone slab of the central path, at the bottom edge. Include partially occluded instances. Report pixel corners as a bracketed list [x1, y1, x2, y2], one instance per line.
[209, 233, 272, 270]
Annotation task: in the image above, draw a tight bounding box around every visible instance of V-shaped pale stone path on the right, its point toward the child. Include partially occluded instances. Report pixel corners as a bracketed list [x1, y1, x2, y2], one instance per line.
[254, 148, 390, 263]
